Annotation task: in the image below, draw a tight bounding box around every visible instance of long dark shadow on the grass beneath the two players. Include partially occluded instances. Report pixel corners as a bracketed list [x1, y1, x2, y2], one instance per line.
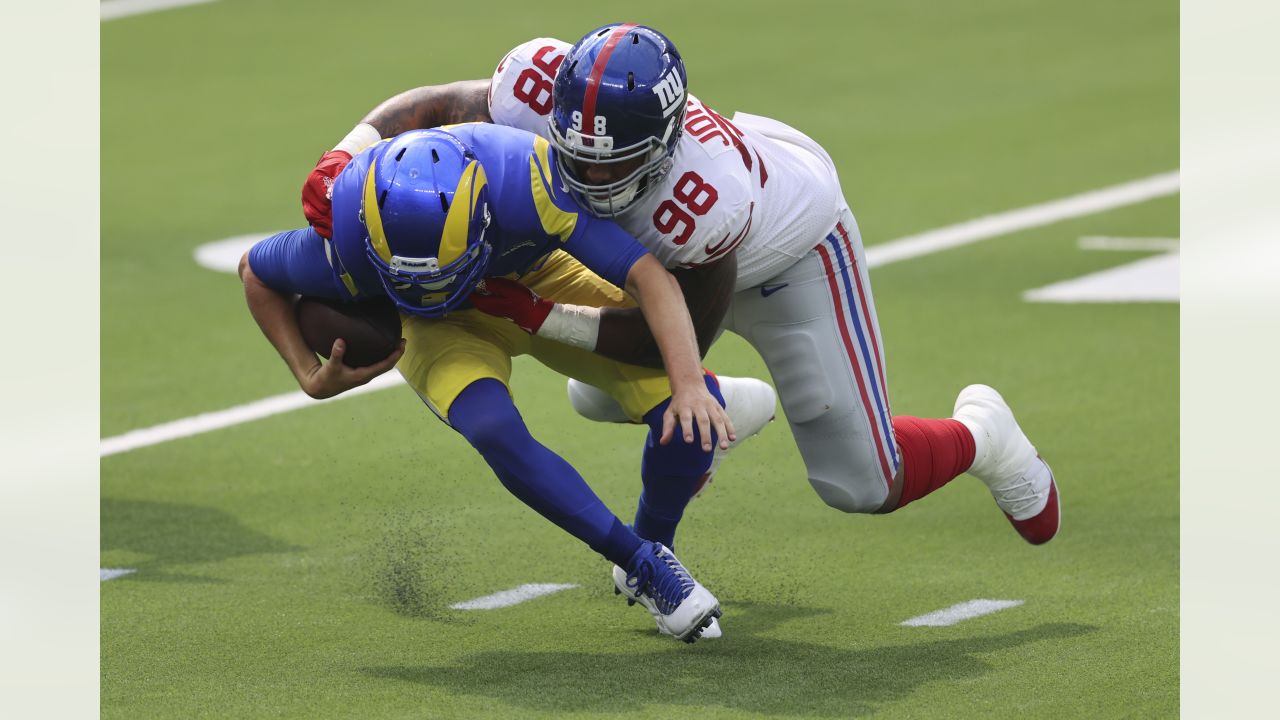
[364, 603, 1097, 717]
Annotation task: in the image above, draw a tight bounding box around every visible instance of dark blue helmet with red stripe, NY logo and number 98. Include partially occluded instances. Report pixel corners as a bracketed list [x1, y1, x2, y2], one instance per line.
[547, 23, 687, 218]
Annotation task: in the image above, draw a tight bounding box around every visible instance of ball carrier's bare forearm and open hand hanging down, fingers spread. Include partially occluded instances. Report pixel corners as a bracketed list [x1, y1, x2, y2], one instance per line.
[626, 255, 735, 443]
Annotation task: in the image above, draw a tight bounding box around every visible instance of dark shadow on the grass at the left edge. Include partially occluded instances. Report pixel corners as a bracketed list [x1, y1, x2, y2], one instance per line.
[100, 497, 301, 583]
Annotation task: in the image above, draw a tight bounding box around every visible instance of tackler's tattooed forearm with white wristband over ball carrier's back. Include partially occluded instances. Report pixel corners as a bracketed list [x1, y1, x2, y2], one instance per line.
[361, 79, 492, 137]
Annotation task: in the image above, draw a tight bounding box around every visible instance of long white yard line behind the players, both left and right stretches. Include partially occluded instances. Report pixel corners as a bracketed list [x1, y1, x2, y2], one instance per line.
[100, 170, 1180, 457]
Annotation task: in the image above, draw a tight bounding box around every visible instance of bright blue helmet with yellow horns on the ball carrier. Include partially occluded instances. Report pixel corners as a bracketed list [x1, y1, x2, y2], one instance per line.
[360, 129, 492, 318]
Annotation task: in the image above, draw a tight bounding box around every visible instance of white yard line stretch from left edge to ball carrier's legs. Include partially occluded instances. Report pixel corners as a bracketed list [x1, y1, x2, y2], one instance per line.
[99, 373, 404, 457]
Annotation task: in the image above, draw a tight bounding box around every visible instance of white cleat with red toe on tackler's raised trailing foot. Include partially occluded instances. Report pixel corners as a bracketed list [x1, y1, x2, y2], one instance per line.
[952, 384, 1061, 544]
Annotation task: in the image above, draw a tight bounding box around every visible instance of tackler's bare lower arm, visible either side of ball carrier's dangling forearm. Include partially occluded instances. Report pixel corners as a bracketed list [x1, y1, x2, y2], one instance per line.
[595, 252, 737, 368]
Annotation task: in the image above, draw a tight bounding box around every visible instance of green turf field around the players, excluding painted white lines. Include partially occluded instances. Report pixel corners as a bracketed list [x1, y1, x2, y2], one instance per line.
[101, 0, 1179, 719]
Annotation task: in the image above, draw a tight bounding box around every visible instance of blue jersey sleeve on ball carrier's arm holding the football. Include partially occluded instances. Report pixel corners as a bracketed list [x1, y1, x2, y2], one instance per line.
[248, 228, 357, 300]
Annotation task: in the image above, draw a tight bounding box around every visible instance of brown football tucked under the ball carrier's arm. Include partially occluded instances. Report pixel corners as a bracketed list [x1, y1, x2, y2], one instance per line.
[294, 297, 401, 368]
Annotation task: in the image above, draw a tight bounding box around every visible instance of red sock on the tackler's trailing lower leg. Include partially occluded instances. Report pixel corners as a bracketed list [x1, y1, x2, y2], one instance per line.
[893, 415, 974, 507]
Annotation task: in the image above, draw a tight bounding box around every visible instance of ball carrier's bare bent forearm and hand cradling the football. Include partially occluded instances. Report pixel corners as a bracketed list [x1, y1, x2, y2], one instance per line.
[239, 252, 404, 400]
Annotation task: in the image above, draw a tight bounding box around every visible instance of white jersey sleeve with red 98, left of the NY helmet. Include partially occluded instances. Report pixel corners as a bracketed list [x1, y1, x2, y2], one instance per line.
[489, 37, 572, 137]
